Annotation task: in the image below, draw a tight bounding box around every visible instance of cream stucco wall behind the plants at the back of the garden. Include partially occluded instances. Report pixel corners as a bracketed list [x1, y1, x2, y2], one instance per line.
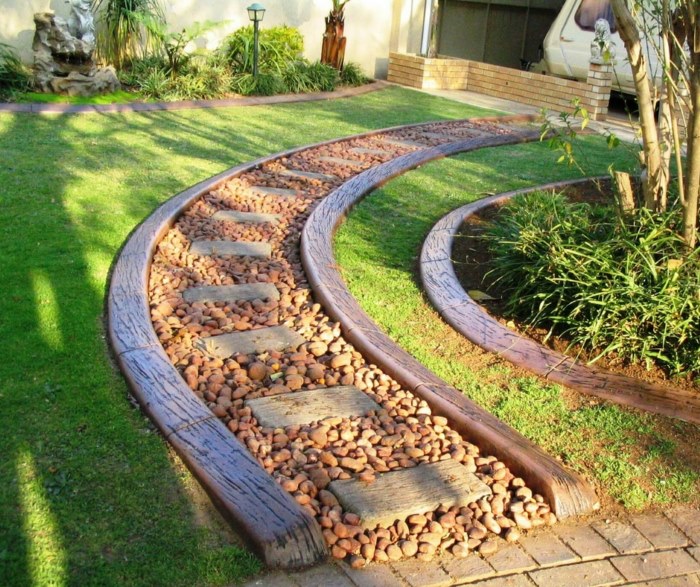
[0, 0, 425, 78]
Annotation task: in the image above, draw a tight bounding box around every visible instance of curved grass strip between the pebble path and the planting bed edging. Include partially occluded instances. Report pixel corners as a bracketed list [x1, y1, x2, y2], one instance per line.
[335, 137, 700, 510]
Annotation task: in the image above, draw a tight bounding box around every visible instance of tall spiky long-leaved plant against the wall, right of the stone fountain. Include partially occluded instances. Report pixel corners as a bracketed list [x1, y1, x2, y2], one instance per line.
[92, 0, 165, 69]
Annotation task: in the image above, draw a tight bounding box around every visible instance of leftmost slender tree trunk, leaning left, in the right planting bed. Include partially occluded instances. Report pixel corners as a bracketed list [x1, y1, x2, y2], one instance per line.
[611, 0, 669, 210]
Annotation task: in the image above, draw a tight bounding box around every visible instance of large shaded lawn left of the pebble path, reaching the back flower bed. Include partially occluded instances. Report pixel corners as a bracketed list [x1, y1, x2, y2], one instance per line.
[0, 89, 498, 586]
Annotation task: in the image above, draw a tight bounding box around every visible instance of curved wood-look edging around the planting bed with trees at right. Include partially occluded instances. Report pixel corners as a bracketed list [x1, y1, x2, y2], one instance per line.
[420, 179, 700, 424]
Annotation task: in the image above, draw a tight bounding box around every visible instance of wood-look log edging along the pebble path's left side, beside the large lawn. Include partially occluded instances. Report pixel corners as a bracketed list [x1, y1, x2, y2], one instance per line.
[106, 116, 540, 569]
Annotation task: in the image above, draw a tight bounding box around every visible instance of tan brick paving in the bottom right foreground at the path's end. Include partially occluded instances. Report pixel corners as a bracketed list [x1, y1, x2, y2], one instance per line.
[244, 507, 700, 587]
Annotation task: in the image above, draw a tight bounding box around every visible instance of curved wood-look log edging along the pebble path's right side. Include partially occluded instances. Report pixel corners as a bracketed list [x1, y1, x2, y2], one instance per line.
[301, 118, 599, 518]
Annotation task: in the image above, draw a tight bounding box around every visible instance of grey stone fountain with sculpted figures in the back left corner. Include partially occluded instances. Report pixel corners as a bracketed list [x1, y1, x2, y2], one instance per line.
[32, 0, 120, 96]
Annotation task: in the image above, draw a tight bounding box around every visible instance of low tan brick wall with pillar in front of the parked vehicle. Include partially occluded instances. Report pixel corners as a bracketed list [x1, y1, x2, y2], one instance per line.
[388, 53, 612, 120]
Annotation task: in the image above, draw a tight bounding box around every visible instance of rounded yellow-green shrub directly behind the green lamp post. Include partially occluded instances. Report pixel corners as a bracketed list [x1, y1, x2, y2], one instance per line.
[221, 26, 304, 74]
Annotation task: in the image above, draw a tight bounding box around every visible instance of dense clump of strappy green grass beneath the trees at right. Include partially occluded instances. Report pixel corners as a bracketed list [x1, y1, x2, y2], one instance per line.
[486, 193, 700, 375]
